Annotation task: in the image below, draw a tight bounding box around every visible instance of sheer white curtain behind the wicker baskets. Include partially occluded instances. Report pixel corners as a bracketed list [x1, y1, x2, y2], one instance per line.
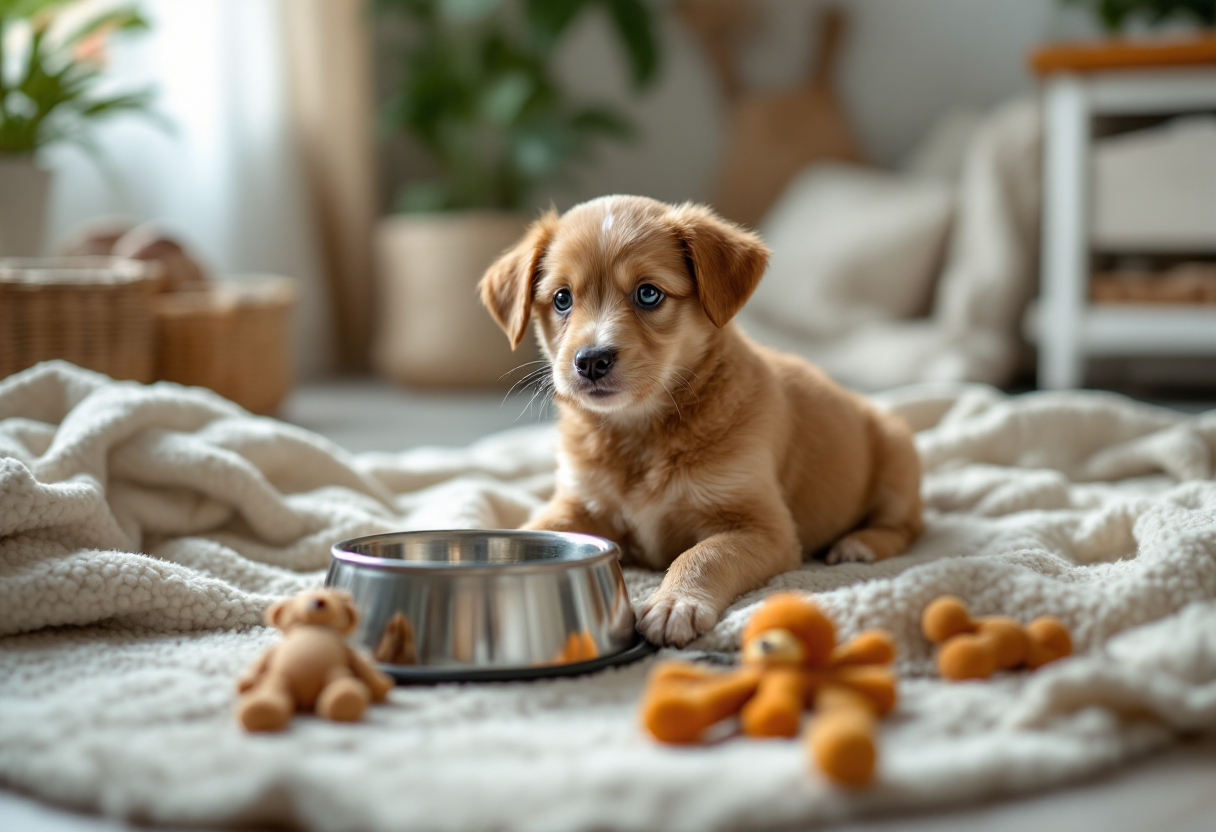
[43, 0, 333, 377]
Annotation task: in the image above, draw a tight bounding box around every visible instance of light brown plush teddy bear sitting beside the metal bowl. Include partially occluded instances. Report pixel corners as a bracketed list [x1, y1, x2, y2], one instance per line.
[236, 589, 393, 731]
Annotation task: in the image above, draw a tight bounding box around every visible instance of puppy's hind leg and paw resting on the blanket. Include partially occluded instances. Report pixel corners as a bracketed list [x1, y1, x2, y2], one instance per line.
[826, 414, 924, 563]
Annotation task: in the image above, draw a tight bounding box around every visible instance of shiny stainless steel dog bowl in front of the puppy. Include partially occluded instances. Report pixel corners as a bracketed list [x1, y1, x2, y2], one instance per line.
[325, 530, 653, 681]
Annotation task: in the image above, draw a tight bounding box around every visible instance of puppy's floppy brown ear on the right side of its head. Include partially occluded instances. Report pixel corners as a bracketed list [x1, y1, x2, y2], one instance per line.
[672, 202, 769, 327]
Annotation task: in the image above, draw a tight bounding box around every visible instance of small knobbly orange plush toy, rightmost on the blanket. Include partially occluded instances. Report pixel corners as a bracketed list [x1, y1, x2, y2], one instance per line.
[921, 595, 1073, 681]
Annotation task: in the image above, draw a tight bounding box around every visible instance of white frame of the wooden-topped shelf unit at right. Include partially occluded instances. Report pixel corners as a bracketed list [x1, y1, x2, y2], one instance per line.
[1024, 67, 1216, 389]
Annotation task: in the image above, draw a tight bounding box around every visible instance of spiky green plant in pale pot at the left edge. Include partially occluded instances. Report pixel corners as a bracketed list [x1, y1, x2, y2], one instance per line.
[0, 0, 152, 257]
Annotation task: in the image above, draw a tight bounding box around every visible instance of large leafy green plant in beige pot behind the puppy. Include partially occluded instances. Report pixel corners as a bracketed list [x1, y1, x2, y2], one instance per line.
[376, 0, 658, 386]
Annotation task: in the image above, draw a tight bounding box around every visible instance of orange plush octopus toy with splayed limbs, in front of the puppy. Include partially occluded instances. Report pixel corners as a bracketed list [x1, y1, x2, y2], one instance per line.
[642, 592, 896, 786]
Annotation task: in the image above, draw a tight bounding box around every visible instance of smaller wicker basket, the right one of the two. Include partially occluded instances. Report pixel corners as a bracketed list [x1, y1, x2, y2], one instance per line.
[156, 276, 295, 414]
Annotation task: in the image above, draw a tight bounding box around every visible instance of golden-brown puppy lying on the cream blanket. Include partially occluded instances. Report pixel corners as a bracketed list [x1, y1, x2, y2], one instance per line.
[480, 196, 923, 646]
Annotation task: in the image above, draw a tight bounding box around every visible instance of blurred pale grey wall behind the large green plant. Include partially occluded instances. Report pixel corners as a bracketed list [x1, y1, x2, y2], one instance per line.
[381, 0, 1097, 208]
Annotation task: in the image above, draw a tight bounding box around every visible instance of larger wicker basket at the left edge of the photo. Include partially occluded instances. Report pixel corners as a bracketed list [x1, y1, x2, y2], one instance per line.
[0, 257, 156, 382]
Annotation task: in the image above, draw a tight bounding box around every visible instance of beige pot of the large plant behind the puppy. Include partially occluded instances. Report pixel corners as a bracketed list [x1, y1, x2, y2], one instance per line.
[375, 212, 537, 387]
